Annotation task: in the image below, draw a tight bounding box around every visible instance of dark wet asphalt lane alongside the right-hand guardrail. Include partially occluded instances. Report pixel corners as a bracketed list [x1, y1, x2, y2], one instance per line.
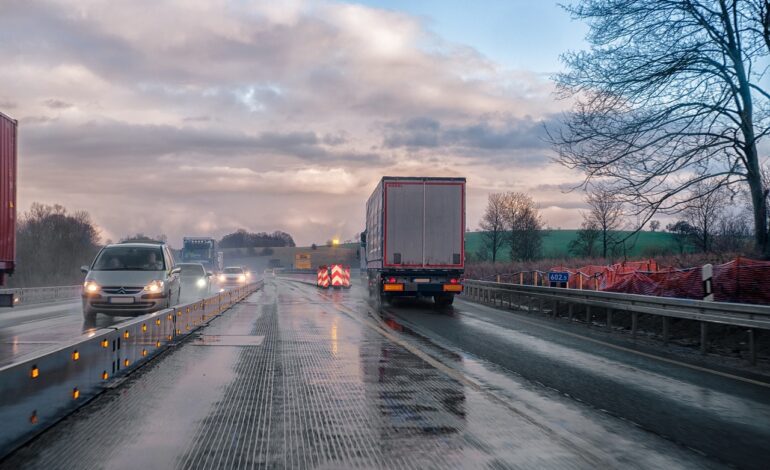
[383, 294, 770, 468]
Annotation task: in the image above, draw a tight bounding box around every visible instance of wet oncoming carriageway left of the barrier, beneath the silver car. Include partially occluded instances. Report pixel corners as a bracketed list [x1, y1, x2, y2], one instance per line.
[0, 284, 222, 366]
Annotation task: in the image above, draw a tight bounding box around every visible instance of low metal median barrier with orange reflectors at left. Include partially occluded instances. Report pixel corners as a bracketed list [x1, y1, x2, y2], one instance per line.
[0, 280, 263, 458]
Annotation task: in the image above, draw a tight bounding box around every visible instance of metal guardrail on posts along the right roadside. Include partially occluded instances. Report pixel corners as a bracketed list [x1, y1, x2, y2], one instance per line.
[463, 280, 770, 364]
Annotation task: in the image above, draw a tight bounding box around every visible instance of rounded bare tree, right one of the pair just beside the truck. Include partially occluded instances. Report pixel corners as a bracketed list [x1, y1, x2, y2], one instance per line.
[504, 192, 543, 261]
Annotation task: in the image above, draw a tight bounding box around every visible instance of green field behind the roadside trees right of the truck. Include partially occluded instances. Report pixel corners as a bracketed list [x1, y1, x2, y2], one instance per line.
[465, 230, 677, 258]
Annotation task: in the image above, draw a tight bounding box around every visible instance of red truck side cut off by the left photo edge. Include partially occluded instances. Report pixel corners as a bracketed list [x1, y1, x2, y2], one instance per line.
[0, 113, 18, 306]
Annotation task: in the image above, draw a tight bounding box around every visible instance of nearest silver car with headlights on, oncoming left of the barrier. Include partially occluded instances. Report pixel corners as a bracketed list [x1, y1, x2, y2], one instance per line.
[80, 243, 181, 322]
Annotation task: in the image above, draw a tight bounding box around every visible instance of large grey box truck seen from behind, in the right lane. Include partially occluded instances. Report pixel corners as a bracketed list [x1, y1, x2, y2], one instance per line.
[361, 176, 465, 307]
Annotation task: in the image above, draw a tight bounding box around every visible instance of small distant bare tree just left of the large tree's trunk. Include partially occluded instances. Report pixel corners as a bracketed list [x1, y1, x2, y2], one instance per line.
[683, 182, 730, 253]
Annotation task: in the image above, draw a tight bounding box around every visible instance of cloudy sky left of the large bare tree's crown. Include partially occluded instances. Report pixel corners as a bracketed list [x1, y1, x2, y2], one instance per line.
[0, 0, 585, 246]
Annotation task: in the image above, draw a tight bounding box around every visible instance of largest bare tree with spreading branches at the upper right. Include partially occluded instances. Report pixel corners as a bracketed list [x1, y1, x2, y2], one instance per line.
[549, 0, 770, 255]
